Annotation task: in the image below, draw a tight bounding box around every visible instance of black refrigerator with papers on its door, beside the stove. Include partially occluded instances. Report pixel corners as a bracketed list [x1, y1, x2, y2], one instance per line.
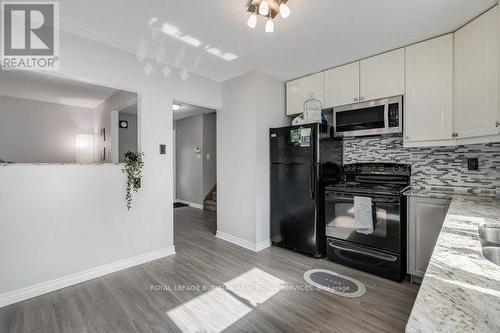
[270, 124, 343, 258]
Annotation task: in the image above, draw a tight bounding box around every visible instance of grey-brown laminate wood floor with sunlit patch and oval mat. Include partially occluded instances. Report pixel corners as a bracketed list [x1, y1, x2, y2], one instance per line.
[0, 207, 418, 333]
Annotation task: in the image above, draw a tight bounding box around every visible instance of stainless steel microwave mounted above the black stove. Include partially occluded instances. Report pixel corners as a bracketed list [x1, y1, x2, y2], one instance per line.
[333, 96, 403, 137]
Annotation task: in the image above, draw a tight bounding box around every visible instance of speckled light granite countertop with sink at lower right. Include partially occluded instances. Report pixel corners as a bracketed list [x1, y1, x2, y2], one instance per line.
[406, 192, 500, 332]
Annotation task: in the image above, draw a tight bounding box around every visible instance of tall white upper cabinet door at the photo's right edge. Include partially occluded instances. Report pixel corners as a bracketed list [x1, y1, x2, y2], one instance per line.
[454, 7, 499, 139]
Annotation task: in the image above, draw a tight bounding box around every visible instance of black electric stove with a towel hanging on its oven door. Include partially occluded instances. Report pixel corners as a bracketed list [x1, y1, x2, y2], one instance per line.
[325, 163, 411, 281]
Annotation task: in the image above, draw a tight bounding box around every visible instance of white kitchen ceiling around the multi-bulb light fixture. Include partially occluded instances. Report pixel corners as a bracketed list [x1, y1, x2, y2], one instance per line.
[60, 0, 497, 81]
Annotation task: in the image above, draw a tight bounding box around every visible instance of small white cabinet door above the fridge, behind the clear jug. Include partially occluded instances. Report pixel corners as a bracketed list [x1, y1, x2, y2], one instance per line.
[286, 73, 324, 115]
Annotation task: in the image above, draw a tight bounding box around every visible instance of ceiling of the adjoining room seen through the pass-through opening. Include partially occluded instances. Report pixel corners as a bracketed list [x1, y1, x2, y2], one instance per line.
[0, 71, 118, 108]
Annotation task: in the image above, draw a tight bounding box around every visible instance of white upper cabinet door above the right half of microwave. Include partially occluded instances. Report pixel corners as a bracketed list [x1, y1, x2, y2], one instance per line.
[360, 49, 404, 101]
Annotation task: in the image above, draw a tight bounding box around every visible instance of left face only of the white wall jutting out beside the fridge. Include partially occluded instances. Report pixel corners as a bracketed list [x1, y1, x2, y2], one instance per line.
[217, 72, 257, 244]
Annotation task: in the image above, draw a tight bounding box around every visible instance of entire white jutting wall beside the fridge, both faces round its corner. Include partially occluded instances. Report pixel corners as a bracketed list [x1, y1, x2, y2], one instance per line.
[217, 71, 290, 250]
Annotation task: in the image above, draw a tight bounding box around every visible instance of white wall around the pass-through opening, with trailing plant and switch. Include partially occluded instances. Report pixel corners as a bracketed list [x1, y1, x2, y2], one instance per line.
[0, 29, 221, 304]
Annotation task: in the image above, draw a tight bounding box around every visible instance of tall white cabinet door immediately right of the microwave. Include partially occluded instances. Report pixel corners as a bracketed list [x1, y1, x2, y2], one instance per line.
[404, 34, 453, 143]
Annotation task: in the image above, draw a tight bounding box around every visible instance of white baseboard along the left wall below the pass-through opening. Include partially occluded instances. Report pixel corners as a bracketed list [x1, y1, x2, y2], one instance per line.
[0, 245, 175, 308]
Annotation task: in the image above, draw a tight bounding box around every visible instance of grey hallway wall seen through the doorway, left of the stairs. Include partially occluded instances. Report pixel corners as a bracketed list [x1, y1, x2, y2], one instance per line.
[175, 114, 204, 205]
